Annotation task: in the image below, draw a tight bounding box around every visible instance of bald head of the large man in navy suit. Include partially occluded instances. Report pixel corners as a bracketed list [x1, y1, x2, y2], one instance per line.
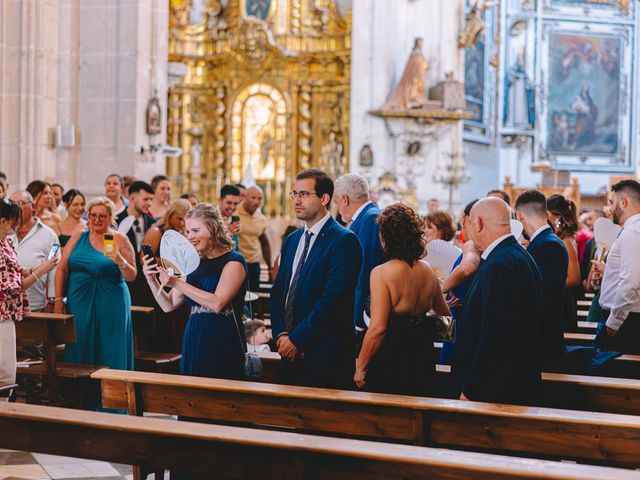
[469, 197, 511, 250]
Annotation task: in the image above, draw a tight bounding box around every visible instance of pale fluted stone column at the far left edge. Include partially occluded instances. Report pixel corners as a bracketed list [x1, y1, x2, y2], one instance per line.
[0, 0, 58, 188]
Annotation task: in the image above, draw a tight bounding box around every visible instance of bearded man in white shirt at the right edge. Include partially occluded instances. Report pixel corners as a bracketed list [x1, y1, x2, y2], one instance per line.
[596, 180, 640, 353]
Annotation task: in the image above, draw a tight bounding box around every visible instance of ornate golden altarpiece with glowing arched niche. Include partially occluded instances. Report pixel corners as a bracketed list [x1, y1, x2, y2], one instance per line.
[167, 0, 351, 216]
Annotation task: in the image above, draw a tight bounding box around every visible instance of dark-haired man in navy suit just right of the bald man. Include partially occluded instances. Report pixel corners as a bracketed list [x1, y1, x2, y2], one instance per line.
[515, 190, 569, 371]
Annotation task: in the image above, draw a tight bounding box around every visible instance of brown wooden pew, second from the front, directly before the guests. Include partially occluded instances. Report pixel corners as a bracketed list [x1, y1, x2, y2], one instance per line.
[93, 370, 640, 468]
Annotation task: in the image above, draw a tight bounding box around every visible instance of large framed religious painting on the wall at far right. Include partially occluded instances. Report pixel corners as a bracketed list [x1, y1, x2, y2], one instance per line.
[536, 21, 634, 172]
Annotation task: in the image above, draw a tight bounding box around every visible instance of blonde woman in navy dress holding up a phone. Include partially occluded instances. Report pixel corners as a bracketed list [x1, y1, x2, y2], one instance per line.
[144, 203, 247, 379]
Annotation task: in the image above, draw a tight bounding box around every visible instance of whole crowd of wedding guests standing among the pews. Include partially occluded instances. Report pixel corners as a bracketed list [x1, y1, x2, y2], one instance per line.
[0, 169, 640, 404]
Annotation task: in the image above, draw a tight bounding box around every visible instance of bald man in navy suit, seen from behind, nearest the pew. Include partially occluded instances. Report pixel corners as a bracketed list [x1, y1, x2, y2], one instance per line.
[453, 197, 542, 403]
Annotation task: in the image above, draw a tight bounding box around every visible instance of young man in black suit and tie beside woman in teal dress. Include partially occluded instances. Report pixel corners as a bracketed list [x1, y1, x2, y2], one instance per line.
[116, 180, 155, 305]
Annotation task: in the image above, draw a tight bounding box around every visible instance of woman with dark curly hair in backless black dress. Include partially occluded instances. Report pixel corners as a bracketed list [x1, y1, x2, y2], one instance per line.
[354, 203, 451, 396]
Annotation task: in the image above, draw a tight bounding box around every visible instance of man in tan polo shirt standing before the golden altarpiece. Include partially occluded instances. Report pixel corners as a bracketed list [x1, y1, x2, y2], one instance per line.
[238, 185, 273, 291]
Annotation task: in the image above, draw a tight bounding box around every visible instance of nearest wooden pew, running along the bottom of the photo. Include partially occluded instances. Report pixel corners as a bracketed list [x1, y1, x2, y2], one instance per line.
[0, 404, 640, 480]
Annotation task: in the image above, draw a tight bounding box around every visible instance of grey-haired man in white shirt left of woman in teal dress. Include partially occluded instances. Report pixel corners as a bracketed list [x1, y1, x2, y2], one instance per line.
[9, 190, 60, 312]
